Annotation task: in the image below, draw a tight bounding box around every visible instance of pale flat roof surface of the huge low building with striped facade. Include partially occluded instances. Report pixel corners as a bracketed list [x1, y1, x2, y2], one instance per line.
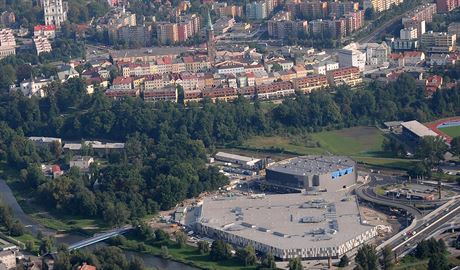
[199, 191, 372, 249]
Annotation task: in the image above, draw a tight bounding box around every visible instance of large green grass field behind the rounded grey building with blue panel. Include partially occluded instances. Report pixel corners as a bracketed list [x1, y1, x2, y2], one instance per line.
[241, 127, 413, 170]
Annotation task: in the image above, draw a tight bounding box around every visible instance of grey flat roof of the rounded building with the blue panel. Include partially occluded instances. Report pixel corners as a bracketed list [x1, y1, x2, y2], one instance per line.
[268, 156, 355, 175]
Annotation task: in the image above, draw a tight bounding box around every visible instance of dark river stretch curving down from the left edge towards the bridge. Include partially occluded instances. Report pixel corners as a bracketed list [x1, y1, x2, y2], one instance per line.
[0, 179, 55, 235]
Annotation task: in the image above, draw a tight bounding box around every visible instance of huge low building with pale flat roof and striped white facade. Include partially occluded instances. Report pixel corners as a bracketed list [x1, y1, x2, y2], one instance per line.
[190, 191, 377, 260]
